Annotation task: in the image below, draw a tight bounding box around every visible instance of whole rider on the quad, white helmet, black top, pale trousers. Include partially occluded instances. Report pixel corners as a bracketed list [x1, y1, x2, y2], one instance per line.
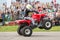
[24, 4, 37, 25]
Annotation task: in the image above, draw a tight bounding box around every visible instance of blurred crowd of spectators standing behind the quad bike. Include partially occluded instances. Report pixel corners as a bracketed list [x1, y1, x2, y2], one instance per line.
[0, 1, 60, 24]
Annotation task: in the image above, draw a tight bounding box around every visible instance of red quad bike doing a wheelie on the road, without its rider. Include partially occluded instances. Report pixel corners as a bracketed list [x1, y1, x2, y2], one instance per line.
[16, 14, 52, 37]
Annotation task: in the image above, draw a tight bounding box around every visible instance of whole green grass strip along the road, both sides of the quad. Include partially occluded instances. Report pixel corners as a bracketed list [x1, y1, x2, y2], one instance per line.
[0, 26, 60, 32]
